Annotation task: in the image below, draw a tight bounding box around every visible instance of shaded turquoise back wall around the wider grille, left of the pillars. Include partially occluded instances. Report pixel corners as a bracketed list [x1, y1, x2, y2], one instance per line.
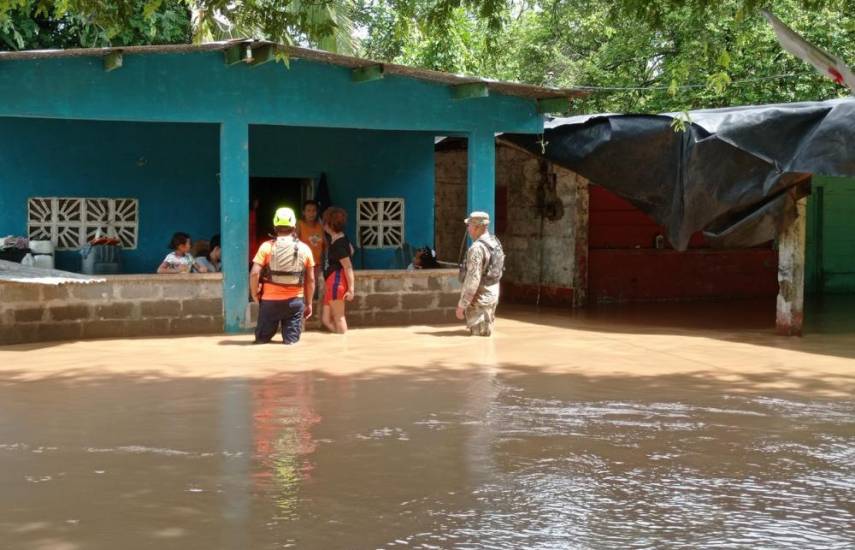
[0, 118, 220, 273]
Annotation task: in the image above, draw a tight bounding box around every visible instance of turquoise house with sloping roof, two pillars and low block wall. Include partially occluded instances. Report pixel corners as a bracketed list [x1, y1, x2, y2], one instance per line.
[0, 41, 578, 341]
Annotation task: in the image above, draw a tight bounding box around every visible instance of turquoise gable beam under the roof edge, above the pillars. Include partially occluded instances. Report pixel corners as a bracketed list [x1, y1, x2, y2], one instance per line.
[0, 52, 543, 133]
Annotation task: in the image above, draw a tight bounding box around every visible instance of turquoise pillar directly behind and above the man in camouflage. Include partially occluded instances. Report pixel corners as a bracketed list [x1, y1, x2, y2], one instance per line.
[466, 130, 496, 221]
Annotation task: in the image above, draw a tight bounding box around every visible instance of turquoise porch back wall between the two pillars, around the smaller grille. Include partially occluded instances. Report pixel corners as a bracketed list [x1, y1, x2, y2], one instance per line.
[249, 126, 434, 269]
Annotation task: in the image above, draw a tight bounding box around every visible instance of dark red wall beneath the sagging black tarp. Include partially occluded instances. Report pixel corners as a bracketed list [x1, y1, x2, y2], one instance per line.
[588, 185, 778, 304]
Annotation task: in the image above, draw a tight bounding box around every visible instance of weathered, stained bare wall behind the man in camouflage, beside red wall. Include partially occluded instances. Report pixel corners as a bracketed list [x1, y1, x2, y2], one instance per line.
[436, 143, 588, 306]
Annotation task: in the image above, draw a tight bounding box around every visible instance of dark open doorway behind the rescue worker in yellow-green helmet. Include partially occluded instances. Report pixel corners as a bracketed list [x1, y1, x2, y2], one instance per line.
[249, 178, 314, 242]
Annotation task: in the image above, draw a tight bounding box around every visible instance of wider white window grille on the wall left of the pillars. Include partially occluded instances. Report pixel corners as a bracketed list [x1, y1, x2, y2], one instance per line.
[27, 197, 139, 250]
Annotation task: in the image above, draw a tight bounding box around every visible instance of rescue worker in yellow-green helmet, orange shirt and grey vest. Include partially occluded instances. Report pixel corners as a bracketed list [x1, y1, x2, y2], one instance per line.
[249, 208, 315, 344]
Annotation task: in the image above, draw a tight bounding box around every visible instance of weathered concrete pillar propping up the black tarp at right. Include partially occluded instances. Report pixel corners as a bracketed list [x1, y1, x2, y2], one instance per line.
[776, 197, 807, 336]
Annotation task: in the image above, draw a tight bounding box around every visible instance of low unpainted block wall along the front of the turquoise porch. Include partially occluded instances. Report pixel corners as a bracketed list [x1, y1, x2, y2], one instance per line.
[0, 270, 468, 344]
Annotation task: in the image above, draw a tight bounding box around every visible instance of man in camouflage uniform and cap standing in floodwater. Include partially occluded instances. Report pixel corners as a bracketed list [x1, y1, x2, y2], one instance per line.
[457, 212, 499, 336]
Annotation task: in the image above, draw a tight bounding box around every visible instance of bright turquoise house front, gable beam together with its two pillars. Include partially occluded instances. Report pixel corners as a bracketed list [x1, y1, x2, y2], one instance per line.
[0, 51, 543, 332]
